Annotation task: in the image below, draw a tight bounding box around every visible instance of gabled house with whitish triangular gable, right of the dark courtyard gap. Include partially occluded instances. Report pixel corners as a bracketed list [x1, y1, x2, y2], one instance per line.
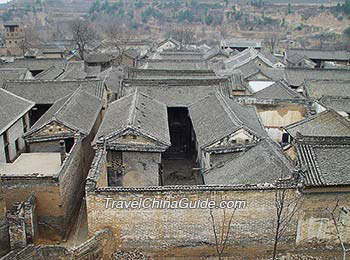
[189, 93, 267, 170]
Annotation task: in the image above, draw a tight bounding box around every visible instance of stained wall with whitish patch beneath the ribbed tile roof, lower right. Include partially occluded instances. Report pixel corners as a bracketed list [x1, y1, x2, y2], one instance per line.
[296, 191, 350, 244]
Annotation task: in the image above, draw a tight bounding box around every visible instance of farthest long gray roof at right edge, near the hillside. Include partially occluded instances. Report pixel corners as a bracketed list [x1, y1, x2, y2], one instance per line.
[287, 49, 350, 61]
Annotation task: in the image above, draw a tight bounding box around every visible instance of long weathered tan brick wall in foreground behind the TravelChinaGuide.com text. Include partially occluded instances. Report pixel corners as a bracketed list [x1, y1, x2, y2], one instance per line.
[87, 189, 296, 248]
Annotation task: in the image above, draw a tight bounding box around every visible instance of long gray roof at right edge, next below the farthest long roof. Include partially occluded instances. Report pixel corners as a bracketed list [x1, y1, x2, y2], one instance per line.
[285, 68, 350, 86]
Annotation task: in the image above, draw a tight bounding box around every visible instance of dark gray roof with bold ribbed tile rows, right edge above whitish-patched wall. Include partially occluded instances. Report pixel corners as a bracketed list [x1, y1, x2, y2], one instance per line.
[297, 144, 350, 187]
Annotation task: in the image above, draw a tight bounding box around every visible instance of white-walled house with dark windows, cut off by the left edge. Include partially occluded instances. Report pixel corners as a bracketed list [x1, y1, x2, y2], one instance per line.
[0, 88, 35, 163]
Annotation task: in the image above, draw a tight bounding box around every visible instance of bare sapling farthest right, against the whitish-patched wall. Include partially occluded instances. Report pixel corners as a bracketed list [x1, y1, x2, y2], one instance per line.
[326, 199, 350, 260]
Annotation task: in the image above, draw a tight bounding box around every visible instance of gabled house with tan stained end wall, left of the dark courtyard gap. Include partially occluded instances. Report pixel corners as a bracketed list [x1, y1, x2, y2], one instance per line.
[95, 91, 171, 186]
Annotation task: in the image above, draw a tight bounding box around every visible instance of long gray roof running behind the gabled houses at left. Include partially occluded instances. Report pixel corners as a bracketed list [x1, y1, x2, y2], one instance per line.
[3, 80, 104, 104]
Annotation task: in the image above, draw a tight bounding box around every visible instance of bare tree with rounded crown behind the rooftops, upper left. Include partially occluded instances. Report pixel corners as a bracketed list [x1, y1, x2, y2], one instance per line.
[70, 19, 97, 59]
